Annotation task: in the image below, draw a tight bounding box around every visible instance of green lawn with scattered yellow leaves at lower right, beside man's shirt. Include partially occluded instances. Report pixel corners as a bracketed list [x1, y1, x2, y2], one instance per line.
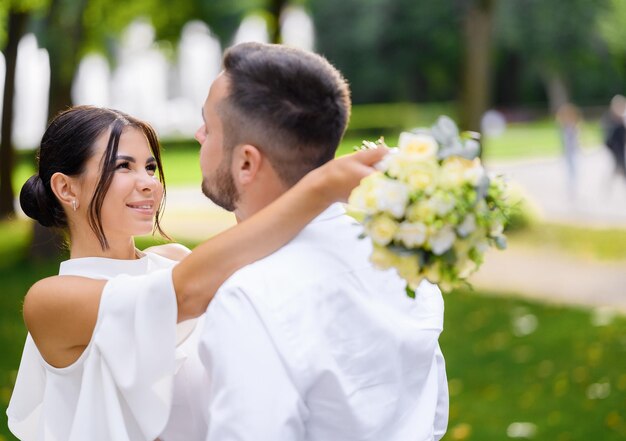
[440, 292, 626, 441]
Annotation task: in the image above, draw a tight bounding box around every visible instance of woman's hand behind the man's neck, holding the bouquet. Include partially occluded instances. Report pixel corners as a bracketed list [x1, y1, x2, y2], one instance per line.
[305, 147, 389, 204]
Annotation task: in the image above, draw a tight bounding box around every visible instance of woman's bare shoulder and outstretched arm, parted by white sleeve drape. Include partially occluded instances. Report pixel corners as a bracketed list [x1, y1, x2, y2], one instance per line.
[24, 149, 386, 366]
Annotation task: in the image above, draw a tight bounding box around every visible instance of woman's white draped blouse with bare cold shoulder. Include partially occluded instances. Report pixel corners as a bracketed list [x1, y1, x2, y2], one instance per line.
[7, 253, 204, 441]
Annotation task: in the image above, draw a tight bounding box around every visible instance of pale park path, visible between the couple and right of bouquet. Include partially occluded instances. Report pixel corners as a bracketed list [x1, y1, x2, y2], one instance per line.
[163, 148, 626, 313]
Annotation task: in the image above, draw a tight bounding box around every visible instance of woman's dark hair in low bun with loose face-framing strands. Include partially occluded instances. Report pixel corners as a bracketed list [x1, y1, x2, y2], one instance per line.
[20, 106, 167, 249]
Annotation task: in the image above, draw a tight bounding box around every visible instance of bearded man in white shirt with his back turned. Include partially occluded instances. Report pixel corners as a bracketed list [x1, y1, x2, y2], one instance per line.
[196, 43, 448, 441]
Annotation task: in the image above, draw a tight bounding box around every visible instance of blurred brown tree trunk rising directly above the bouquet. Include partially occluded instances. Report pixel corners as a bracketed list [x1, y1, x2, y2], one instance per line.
[460, 0, 496, 136]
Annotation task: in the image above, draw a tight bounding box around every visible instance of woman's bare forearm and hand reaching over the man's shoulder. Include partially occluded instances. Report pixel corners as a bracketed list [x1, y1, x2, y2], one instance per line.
[172, 150, 385, 321]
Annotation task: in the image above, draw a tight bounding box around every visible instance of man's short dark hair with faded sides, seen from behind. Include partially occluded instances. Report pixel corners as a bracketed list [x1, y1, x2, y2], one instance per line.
[218, 43, 350, 186]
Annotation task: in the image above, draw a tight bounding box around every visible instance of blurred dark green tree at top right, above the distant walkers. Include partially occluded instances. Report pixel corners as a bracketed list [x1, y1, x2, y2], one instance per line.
[495, 0, 608, 111]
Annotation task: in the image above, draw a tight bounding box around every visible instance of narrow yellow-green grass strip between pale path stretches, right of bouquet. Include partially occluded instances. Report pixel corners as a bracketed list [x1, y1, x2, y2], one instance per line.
[508, 224, 626, 261]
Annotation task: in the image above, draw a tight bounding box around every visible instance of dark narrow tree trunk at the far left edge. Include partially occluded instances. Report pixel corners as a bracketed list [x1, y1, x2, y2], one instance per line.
[0, 11, 28, 218]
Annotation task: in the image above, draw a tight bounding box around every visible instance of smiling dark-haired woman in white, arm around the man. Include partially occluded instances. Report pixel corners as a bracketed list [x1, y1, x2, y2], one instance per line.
[7, 106, 385, 441]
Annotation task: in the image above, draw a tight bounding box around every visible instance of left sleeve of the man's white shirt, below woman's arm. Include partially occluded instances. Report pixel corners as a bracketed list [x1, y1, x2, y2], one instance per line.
[199, 289, 306, 441]
